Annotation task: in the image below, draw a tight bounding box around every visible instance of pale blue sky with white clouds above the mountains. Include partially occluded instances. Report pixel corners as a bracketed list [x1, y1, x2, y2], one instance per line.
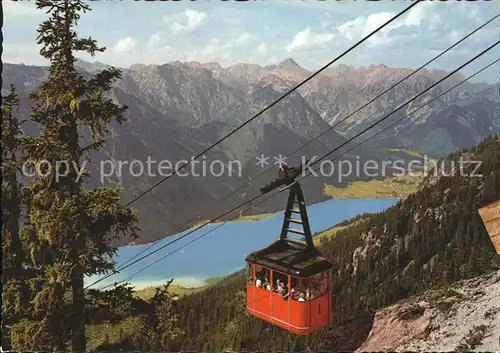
[2, 0, 500, 83]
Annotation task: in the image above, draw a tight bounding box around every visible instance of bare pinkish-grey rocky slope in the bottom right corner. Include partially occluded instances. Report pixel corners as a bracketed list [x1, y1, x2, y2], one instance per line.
[356, 271, 500, 352]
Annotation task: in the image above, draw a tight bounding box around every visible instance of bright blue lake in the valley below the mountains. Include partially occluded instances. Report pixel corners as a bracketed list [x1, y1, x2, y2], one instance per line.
[85, 199, 398, 289]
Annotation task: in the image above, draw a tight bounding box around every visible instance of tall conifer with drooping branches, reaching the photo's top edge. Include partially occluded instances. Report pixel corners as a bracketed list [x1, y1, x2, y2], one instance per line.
[16, 0, 138, 352]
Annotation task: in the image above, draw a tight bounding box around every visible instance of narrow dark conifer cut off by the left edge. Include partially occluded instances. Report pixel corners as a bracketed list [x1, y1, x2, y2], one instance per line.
[2, 85, 27, 348]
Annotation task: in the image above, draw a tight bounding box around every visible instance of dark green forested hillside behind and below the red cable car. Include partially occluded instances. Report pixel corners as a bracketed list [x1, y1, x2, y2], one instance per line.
[85, 136, 500, 352]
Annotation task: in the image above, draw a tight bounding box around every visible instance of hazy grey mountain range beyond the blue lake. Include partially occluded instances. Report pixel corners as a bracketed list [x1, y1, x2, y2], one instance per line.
[2, 59, 500, 245]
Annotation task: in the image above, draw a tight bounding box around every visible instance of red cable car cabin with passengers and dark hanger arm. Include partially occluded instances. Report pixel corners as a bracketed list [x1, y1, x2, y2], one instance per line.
[246, 183, 332, 335]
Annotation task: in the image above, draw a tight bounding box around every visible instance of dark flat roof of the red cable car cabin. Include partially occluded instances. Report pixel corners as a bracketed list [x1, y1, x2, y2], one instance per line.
[246, 238, 332, 277]
